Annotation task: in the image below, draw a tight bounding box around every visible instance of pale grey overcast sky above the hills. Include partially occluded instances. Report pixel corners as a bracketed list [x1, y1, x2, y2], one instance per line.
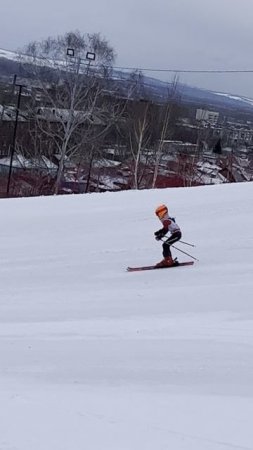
[0, 0, 253, 98]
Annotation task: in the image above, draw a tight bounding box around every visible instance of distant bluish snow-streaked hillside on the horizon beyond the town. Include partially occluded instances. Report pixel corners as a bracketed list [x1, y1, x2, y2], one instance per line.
[0, 49, 253, 113]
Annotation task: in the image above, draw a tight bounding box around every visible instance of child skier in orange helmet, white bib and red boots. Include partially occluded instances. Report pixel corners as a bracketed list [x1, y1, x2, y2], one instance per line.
[154, 205, 182, 267]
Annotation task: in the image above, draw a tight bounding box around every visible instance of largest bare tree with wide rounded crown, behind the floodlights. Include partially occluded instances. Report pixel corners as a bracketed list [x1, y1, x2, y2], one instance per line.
[22, 31, 115, 194]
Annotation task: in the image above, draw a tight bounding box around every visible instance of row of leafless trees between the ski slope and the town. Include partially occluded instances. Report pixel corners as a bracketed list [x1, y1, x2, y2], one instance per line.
[0, 31, 249, 194]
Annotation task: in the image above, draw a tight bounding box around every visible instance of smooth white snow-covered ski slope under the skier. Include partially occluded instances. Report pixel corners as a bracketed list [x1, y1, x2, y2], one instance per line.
[0, 183, 253, 450]
